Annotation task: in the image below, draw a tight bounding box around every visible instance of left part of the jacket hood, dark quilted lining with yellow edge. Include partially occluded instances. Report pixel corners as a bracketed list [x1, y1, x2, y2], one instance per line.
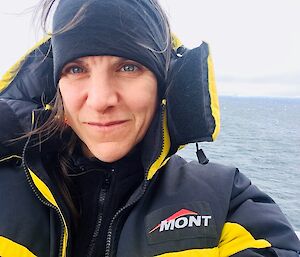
[0, 39, 56, 158]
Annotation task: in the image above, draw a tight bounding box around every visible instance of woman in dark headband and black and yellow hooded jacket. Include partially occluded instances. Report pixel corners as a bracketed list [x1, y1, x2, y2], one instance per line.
[0, 0, 300, 254]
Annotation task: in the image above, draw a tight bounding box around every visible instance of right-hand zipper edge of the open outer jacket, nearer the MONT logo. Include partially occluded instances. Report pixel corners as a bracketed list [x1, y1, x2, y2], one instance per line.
[104, 103, 166, 257]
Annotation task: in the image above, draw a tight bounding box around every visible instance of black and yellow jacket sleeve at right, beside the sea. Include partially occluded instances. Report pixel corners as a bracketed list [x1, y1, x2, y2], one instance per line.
[219, 170, 300, 257]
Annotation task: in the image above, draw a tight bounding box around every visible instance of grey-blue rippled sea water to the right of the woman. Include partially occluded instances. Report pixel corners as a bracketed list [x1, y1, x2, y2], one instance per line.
[179, 97, 300, 231]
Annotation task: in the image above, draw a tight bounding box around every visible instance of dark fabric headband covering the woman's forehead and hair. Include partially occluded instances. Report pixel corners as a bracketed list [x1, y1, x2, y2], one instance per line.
[52, 0, 168, 91]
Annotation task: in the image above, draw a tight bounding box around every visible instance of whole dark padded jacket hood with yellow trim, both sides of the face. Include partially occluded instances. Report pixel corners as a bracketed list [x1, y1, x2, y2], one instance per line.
[0, 37, 220, 179]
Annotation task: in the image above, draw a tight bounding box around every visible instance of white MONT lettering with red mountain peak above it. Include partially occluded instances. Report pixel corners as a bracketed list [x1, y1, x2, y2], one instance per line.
[149, 209, 211, 234]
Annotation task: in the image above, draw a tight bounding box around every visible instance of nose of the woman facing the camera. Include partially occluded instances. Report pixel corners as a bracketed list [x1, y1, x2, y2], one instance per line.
[86, 73, 119, 112]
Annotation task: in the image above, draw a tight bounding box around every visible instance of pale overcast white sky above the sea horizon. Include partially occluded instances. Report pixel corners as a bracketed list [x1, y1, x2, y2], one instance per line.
[0, 0, 300, 97]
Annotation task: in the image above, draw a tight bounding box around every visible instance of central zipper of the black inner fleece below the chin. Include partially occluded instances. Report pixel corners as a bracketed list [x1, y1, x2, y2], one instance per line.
[87, 169, 115, 257]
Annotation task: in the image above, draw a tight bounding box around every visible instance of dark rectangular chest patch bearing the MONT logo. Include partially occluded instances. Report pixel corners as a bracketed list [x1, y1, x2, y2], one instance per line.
[146, 202, 216, 244]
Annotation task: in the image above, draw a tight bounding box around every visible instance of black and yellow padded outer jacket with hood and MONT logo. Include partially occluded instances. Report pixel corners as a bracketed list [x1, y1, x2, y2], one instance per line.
[0, 39, 300, 257]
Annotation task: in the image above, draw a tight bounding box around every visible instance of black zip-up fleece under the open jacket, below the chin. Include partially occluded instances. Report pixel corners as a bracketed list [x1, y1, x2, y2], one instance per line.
[70, 147, 144, 257]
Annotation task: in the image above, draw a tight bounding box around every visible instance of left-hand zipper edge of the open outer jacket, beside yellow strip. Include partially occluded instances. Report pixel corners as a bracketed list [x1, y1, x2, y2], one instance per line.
[22, 137, 65, 257]
